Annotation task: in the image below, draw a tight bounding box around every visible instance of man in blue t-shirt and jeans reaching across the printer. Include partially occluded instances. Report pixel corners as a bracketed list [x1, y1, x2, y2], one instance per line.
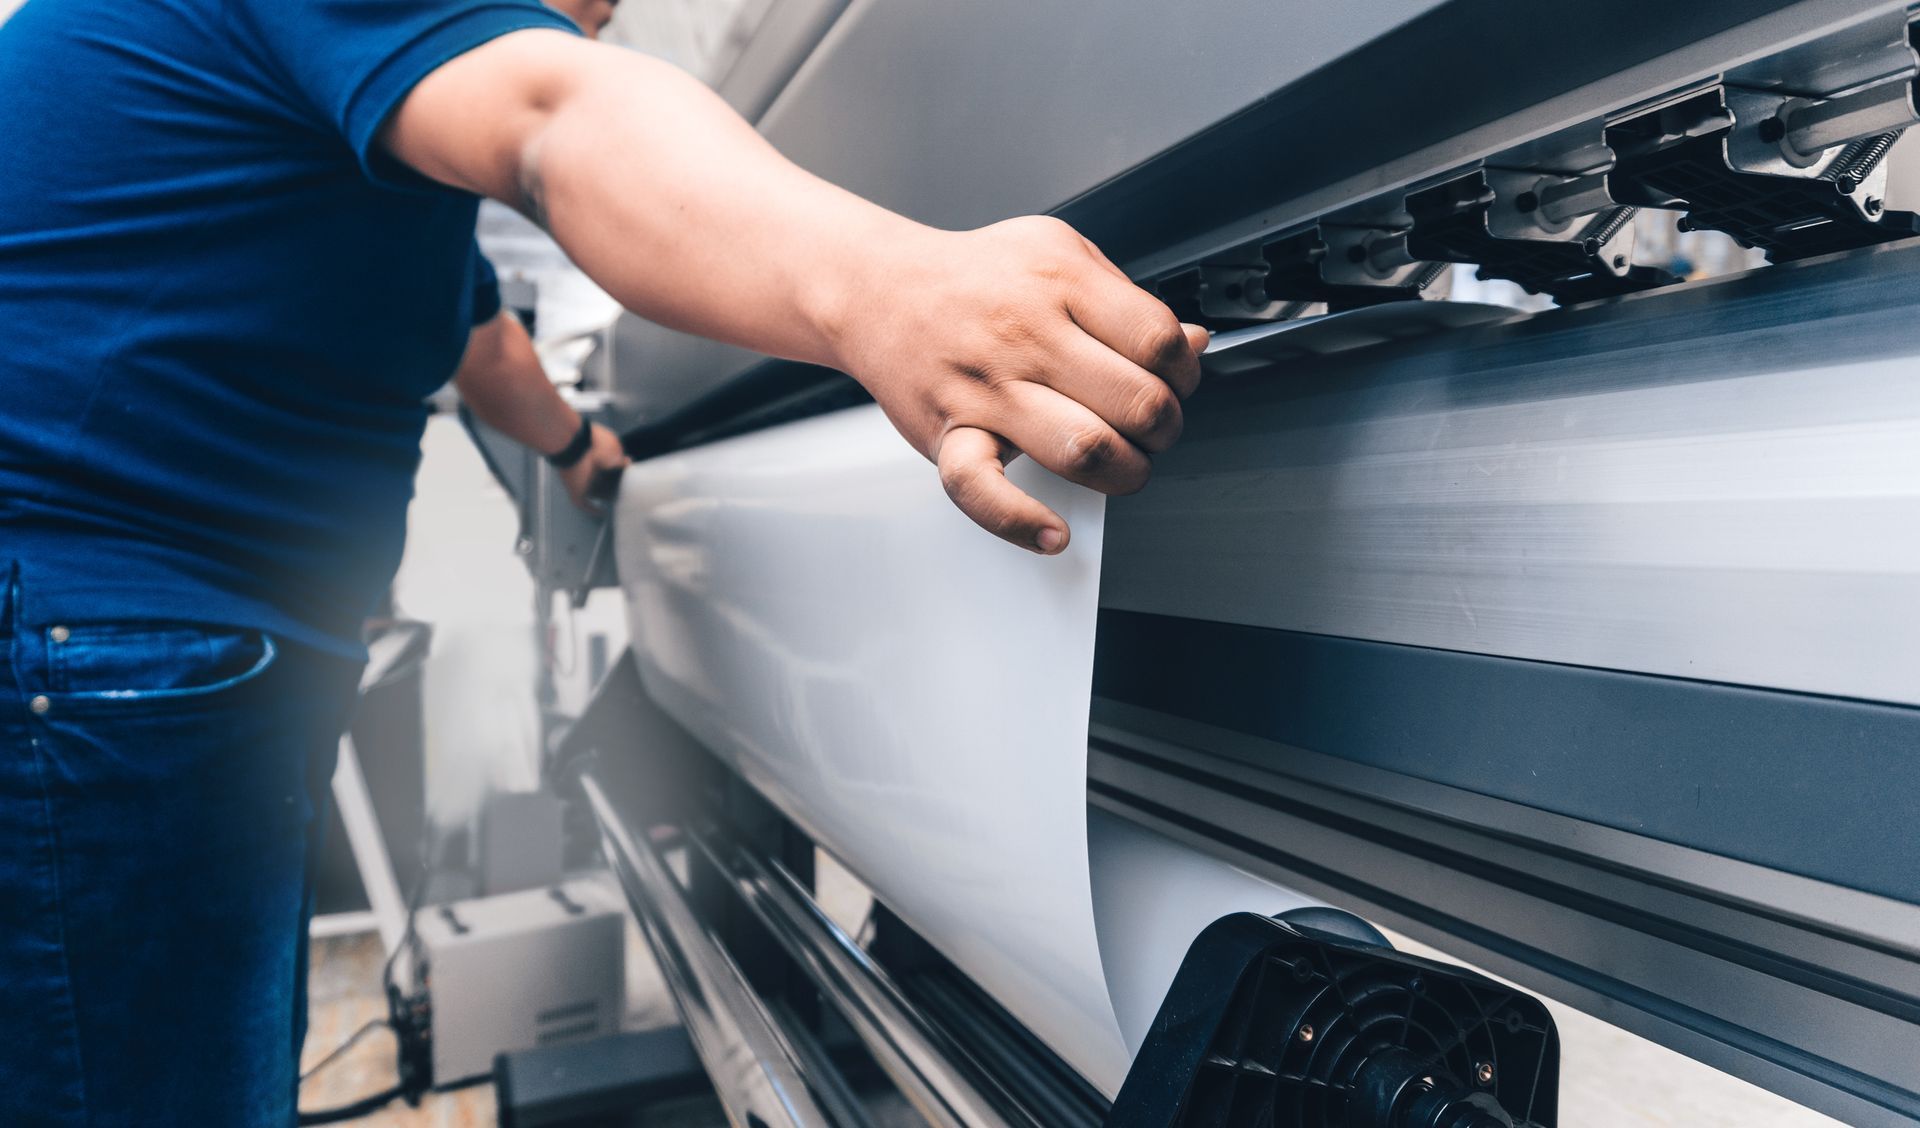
[0, 0, 1206, 1124]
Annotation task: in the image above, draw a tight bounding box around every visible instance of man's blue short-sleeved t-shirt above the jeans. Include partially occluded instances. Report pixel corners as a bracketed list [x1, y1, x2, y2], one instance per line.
[0, 0, 576, 654]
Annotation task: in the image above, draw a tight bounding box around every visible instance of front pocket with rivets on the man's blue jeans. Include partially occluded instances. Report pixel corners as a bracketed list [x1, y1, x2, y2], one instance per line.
[48, 623, 276, 702]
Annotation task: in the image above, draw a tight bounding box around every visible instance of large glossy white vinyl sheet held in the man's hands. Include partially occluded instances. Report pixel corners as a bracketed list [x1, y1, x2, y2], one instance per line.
[614, 407, 1306, 1095]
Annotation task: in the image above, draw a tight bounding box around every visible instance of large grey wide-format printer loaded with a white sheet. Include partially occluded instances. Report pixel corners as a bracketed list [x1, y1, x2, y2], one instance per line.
[499, 0, 1920, 1126]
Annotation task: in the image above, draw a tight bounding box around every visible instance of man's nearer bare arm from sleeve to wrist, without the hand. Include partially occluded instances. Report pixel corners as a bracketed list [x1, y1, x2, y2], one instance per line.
[394, 33, 913, 368]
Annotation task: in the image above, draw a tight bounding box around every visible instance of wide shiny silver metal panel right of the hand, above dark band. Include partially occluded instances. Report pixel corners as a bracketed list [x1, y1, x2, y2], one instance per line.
[1100, 244, 1920, 713]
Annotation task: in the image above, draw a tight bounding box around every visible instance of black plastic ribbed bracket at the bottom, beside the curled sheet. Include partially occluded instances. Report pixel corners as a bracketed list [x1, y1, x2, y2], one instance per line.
[1106, 913, 1559, 1128]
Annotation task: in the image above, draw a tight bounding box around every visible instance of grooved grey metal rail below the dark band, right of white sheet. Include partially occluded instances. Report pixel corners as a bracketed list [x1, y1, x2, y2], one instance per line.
[1089, 700, 1920, 1128]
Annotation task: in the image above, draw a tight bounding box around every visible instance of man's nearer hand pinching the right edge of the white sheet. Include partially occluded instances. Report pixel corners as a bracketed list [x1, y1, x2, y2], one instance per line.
[839, 217, 1208, 554]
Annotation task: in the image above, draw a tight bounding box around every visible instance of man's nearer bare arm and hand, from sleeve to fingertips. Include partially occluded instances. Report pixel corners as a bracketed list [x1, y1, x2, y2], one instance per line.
[384, 31, 1206, 552]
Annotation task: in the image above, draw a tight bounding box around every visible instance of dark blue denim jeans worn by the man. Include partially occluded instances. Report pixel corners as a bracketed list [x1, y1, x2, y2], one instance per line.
[0, 574, 359, 1128]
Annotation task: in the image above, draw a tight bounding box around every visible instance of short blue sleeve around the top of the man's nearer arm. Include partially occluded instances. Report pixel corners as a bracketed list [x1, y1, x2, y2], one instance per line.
[228, 0, 580, 180]
